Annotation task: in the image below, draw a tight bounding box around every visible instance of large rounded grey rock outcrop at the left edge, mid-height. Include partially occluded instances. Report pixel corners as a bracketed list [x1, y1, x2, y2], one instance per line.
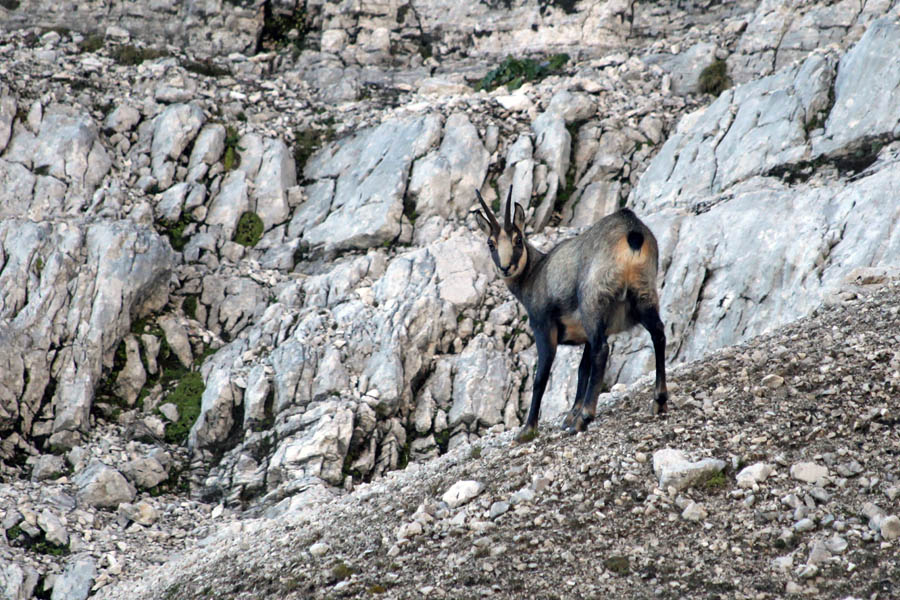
[0, 219, 173, 442]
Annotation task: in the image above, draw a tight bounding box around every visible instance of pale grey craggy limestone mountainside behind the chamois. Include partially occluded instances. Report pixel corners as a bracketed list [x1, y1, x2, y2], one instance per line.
[0, 0, 900, 599]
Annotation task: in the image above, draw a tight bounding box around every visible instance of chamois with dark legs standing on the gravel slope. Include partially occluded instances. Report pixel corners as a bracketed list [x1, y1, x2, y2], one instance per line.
[474, 186, 668, 441]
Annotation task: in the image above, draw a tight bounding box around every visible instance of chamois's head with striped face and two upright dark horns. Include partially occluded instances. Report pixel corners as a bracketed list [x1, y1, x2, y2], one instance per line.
[475, 186, 528, 279]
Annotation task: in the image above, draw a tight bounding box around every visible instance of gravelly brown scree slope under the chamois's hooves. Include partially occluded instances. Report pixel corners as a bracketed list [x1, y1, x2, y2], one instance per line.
[99, 281, 900, 599]
